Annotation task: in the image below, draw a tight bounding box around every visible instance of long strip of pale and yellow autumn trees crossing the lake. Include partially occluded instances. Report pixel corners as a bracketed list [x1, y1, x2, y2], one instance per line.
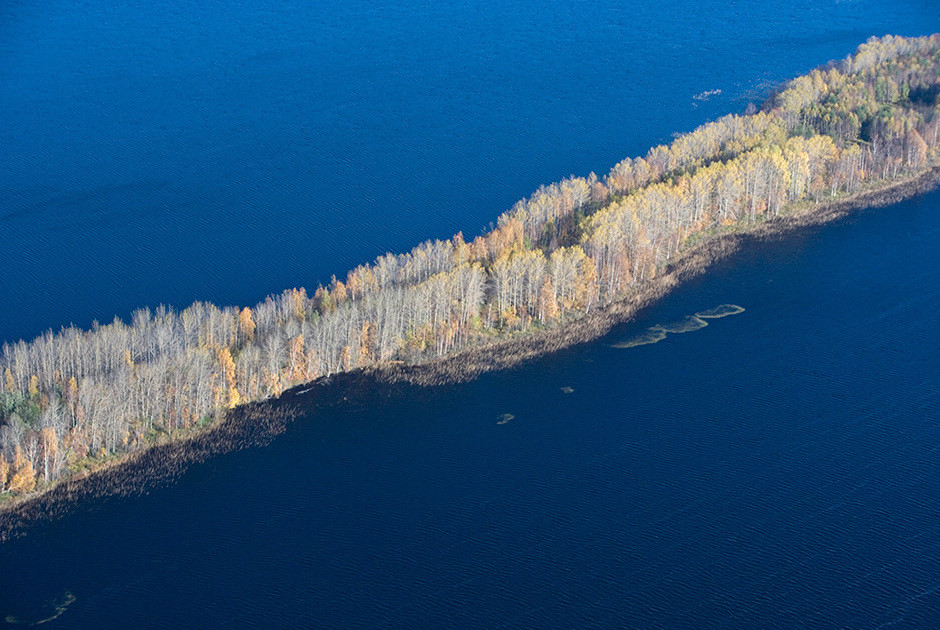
[0, 35, 940, 496]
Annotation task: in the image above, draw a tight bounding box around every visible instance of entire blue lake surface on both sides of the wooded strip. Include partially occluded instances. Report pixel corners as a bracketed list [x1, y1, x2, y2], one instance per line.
[0, 0, 940, 629]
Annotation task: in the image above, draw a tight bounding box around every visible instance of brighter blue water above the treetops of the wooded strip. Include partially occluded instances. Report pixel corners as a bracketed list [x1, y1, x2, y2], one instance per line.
[0, 0, 940, 340]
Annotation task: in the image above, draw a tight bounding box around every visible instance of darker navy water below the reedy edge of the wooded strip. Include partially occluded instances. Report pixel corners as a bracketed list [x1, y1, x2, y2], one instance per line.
[0, 180, 940, 629]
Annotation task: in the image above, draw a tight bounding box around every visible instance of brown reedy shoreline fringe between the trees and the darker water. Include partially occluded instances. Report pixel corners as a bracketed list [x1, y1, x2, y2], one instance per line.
[0, 166, 940, 542]
